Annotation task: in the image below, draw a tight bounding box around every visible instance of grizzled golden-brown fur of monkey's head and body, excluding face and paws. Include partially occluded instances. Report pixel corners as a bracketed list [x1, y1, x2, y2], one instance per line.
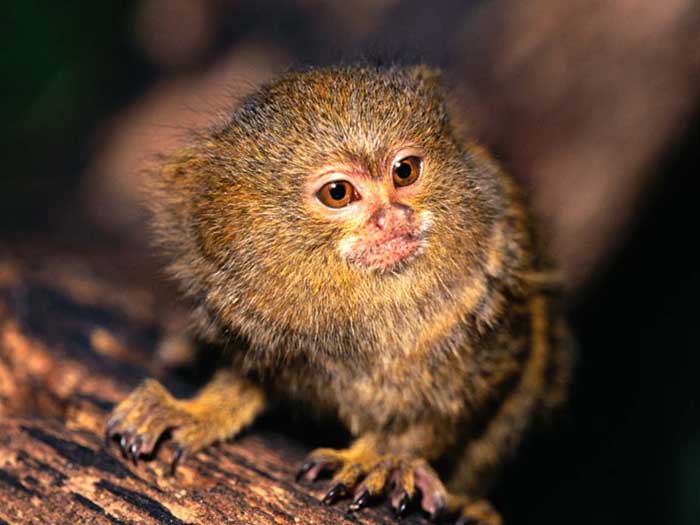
[110, 66, 569, 523]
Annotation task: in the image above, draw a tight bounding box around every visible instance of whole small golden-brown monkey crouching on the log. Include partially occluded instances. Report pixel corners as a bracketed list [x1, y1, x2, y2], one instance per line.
[107, 65, 570, 525]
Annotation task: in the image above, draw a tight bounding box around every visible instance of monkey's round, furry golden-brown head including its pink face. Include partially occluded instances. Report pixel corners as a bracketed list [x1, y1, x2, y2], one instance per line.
[152, 62, 503, 356]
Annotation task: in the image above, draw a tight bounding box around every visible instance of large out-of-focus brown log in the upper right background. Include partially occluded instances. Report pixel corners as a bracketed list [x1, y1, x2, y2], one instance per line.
[455, 0, 700, 287]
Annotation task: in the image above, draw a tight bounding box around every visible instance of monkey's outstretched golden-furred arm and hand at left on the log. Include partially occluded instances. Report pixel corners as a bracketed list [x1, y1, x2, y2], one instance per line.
[106, 370, 265, 471]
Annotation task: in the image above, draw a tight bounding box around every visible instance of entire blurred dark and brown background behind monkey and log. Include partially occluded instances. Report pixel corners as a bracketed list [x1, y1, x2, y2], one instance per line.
[0, 0, 700, 525]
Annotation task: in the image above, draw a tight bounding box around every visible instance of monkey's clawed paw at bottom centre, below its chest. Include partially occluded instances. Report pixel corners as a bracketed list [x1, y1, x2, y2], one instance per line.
[297, 441, 448, 525]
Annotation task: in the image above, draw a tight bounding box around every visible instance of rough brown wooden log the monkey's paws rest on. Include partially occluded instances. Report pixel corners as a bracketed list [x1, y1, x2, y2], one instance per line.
[0, 256, 425, 525]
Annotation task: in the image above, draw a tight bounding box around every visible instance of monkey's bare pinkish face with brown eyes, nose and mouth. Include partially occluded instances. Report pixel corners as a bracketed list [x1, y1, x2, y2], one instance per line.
[305, 148, 430, 271]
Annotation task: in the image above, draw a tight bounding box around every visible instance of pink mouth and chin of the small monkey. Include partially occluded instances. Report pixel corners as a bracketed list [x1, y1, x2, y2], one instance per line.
[347, 233, 423, 271]
